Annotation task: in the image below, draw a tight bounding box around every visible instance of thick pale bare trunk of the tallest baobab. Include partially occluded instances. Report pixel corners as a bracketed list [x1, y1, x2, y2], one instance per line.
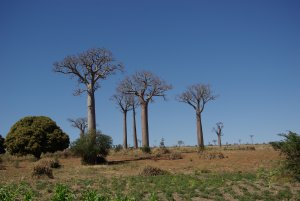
[87, 85, 96, 132]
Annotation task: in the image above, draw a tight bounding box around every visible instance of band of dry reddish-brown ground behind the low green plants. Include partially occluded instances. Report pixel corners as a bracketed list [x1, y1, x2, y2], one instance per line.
[0, 145, 280, 182]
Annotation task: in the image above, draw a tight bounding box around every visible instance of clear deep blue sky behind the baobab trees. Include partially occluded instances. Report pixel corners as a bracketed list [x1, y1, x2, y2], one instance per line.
[0, 0, 300, 145]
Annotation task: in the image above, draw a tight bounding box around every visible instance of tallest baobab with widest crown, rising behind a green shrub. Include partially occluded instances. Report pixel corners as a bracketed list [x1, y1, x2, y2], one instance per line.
[53, 48, 123, 131]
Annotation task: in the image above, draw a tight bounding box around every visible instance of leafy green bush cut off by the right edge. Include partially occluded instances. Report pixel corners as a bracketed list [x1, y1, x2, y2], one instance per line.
[270, 131, 300, 181]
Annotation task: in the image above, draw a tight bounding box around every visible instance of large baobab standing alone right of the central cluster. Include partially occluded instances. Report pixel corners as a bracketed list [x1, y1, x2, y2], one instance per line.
[177, 84, 216, 148]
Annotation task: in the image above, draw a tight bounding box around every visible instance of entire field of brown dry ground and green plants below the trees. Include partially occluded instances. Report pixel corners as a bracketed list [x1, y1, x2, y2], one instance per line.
[0, 145, 300, 201]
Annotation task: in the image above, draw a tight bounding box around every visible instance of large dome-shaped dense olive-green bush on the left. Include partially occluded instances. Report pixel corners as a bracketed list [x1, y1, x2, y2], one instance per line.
[5, 116, 69, 158]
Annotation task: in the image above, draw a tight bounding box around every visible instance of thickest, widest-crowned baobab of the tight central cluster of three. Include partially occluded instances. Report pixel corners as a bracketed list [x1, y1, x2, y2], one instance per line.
[121, 71, 172, 147]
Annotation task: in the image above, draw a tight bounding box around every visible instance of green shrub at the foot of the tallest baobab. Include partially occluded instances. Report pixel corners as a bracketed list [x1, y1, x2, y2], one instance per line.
[71, 131, 112, 165]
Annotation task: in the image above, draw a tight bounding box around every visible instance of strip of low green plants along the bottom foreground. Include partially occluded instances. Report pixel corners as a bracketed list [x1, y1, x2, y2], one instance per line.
[0, 172, 300, 201]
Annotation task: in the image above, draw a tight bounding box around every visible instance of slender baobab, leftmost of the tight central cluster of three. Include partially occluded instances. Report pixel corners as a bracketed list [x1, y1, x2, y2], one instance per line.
[111, 90, 133, 149]
